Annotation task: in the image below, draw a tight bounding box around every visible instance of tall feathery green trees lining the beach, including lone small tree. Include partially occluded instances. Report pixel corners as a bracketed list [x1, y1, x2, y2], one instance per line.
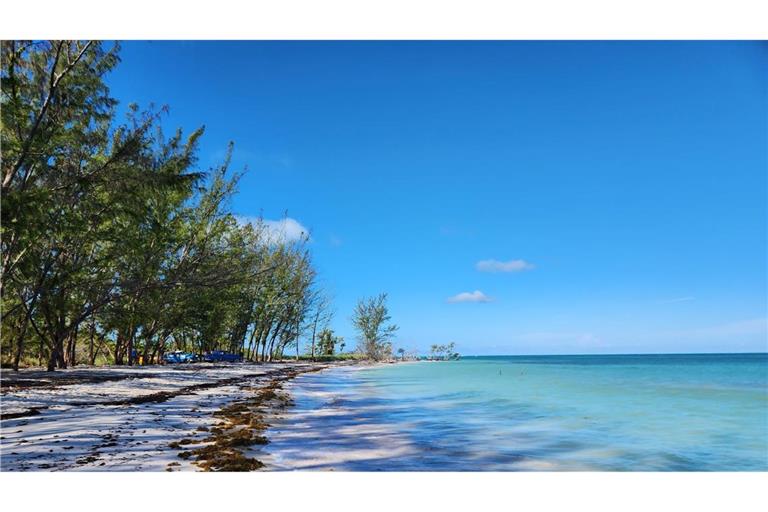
[0, 41, 336, 370]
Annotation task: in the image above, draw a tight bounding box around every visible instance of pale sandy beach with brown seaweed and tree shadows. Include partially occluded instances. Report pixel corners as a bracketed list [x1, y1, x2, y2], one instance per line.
[0, 363, 340, 471]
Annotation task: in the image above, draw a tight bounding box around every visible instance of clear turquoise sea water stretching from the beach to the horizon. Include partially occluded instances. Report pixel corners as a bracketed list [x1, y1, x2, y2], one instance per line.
[275, 354, 768, 471]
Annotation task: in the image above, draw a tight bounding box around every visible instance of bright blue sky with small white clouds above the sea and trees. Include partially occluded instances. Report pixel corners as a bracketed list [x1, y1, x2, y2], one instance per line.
[108, 41, 768, 354]
